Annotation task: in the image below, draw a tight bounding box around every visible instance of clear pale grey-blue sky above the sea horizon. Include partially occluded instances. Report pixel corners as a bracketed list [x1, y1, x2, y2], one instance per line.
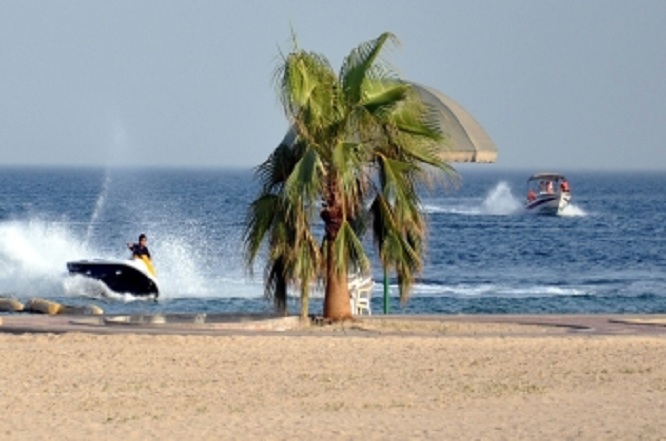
[0, 0, 666, 172]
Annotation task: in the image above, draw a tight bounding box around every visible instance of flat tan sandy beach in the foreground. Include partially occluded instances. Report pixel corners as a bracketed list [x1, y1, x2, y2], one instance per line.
[0, 318, 666, 440]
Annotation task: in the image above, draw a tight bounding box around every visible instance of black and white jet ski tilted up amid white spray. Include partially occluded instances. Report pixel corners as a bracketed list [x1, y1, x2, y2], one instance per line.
[67, 258, 159, 298]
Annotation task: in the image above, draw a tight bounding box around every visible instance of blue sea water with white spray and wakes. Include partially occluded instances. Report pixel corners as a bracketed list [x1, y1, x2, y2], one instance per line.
[0, 165, 666, 314]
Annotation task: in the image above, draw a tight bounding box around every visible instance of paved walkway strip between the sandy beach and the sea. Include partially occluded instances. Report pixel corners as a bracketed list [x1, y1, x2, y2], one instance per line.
[0, 314, 666, 335]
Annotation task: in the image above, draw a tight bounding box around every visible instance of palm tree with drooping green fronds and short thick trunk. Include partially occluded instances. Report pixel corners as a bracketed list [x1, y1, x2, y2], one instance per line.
[245, 33, 455, 320]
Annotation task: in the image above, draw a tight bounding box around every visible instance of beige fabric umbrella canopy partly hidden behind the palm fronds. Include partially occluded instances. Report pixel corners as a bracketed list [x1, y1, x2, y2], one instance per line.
[410, 83, 497, 162]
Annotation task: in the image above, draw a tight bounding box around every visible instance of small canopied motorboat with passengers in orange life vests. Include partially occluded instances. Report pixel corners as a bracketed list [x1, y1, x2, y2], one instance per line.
[525, 173, 571, 216]
